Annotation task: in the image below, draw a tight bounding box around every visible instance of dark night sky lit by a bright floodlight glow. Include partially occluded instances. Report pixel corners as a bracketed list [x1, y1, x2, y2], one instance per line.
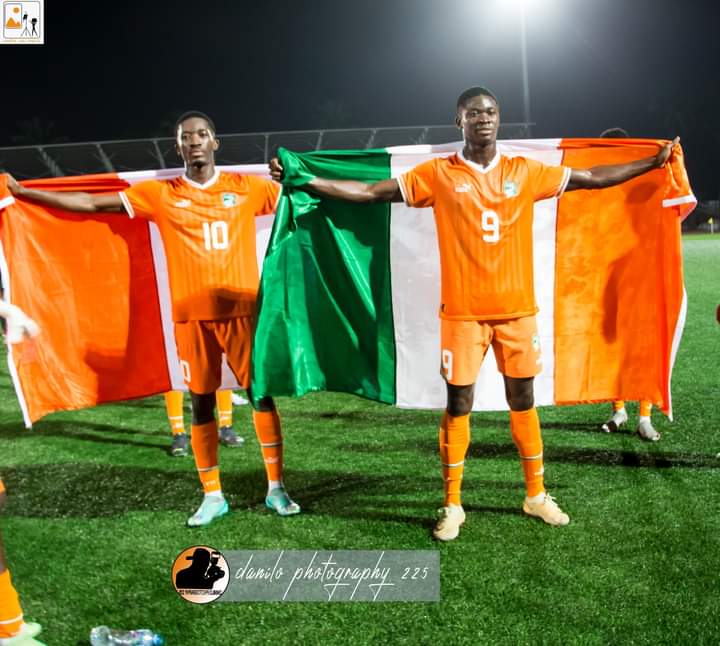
[0, 0, 720, 198]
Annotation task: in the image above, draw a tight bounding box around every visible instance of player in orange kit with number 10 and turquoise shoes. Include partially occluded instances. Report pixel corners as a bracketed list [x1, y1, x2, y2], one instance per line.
[8, 111, 300, 527]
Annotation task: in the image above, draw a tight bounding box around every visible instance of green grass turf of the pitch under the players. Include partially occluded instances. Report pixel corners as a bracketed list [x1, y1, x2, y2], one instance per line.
[0, 236, 720, 646]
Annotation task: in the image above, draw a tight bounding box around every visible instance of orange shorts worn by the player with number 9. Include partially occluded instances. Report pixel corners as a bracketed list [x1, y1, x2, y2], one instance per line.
[440, 316, 542, 386]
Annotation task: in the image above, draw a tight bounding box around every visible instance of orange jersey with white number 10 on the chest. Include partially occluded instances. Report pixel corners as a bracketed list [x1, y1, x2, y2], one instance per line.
[120, 171, 280, 322]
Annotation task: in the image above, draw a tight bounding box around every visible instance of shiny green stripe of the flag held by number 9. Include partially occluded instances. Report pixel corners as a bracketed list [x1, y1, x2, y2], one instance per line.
[252, 148, 396, 403]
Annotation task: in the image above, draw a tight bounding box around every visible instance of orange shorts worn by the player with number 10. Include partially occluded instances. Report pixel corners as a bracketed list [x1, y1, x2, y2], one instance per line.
[175, 316, 255, 395]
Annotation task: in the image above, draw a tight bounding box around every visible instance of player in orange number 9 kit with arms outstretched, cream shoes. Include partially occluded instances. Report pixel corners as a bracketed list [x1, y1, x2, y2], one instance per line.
[270, 87, 677, 540]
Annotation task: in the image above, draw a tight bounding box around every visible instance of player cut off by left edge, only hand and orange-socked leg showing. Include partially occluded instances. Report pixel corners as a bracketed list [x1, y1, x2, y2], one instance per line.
[0, 301, 43, 646]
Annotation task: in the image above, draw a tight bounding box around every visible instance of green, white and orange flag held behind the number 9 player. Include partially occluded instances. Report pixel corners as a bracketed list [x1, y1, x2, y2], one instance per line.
[253, 139, 695, 415]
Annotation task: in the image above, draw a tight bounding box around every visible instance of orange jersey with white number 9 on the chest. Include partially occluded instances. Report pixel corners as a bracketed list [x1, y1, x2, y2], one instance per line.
[398, 153, 570, 320]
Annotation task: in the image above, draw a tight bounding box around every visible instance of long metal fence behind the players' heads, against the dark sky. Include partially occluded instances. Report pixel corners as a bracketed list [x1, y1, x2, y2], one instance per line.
[0, 123, 528, 179]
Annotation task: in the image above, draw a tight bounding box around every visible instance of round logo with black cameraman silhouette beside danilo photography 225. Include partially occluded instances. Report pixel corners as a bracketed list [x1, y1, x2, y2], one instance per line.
[172, 545, 230, 603]
